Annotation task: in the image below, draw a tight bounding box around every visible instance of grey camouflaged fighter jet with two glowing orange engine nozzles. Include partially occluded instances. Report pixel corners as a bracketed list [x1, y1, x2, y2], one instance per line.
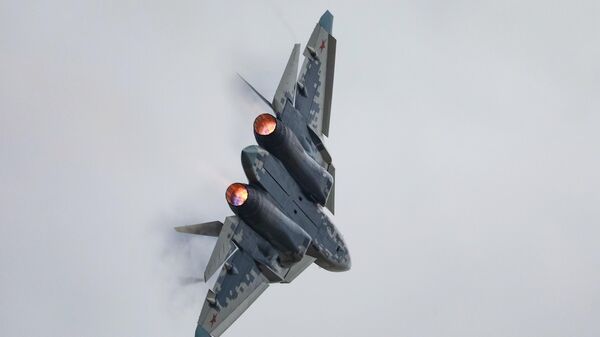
[175, 11, 351, 337]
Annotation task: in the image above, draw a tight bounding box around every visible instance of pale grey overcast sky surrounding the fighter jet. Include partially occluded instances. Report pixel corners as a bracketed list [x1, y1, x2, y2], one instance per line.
[0, 0, 600, 337]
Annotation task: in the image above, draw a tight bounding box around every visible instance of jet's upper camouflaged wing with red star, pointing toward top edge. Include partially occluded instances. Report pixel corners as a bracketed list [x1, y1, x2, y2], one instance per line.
[294, 11, 336, 136]
